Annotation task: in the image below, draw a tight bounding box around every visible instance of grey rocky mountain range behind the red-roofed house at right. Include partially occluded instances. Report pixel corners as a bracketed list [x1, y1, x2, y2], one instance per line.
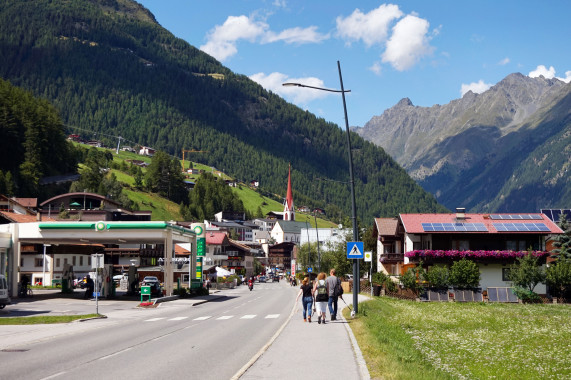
[353, 73, 571, 212]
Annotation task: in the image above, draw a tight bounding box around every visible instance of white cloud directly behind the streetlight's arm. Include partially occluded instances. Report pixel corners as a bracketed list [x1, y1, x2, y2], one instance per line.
[250, 72, 331, 106]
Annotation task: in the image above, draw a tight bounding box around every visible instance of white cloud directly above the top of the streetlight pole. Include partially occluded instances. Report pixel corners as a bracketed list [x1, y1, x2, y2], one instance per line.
[336, 4, 403, 46]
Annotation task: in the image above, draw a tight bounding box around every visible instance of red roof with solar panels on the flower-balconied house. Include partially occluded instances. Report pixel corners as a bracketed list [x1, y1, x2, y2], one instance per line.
[399, 213, 563, 235]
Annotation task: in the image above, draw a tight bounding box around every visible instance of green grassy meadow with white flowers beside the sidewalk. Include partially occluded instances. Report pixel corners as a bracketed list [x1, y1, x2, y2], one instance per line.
[345, 297, 571, 379]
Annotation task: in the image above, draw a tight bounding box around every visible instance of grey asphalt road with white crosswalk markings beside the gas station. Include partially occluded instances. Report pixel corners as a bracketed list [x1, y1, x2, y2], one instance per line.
[0, 282, 297, 380]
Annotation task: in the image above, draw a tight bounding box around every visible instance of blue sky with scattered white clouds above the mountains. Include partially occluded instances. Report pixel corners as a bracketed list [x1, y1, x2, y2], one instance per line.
[138, 0, 571, 127]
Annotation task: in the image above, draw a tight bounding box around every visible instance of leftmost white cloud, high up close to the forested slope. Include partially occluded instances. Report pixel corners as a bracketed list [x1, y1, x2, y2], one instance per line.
[200, 16, 269, 61]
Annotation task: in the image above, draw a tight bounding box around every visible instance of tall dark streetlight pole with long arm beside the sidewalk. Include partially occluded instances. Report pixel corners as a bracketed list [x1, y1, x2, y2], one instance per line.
[282, 61, 360, 313]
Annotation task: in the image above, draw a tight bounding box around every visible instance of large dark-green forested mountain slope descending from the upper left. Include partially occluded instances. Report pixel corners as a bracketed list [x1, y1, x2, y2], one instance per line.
[0, 0, 442, 220]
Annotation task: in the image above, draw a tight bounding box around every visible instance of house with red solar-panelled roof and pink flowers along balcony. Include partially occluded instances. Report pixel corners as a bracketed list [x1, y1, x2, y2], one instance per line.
[375, 209, 563, 294]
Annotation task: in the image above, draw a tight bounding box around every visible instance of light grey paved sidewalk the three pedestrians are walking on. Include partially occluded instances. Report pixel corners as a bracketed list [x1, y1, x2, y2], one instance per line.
[233, 294, 370, 380]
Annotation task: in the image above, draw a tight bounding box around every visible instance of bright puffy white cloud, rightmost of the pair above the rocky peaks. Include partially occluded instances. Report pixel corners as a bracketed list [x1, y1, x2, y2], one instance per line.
[381, 15, 433, 71]
